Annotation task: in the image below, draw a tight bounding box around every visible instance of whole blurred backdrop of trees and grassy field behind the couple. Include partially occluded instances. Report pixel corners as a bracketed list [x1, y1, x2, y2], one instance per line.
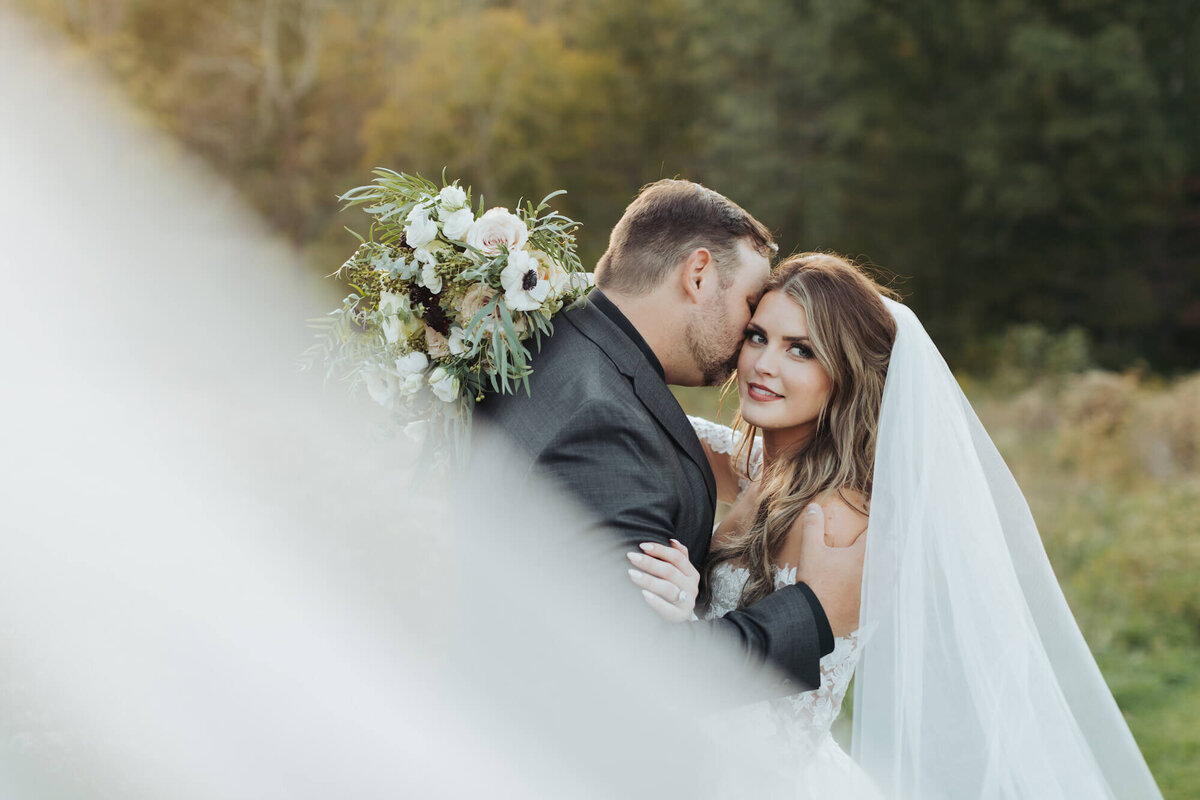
[14, 0, 1200, 798]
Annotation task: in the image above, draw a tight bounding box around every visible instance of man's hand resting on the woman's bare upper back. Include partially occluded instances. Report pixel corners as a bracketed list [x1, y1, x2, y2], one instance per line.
[796, 503, 866, 636]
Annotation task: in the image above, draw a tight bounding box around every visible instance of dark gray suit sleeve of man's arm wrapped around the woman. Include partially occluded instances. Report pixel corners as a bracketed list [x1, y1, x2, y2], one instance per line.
[536, 404, 833, 691]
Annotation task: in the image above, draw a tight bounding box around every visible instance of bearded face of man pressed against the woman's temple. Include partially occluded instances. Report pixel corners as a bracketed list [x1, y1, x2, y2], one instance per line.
[688, 239, 770, 386]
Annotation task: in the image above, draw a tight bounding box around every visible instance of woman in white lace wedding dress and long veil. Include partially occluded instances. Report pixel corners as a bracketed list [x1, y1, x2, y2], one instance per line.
[631, 253, 1162, 800]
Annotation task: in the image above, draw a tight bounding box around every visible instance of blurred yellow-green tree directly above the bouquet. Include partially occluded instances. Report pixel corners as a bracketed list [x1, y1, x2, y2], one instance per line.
[362, 10, 629, 263]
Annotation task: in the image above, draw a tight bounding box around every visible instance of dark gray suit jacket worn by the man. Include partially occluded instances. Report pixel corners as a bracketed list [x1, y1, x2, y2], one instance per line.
[476, 291, 833, 687]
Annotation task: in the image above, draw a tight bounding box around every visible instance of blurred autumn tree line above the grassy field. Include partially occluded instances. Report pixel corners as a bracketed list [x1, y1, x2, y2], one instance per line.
[20, 0, 1200, 371]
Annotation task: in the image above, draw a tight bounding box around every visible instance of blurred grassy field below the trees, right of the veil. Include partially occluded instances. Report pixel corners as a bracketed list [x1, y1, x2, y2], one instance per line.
[678, 371, 1200, 800]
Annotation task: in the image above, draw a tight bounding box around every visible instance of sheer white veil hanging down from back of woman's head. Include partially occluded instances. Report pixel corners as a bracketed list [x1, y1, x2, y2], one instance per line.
[853, 301, 1162, 800]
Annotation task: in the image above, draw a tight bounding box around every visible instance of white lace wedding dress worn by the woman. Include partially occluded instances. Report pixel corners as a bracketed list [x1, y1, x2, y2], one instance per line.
[689, 417, 882, 800]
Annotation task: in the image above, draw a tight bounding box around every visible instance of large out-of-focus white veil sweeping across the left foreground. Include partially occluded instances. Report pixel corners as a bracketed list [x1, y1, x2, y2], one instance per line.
[0, 8, 787, 800]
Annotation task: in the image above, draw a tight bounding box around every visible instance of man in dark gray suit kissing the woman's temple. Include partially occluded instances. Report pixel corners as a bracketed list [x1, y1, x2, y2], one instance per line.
[479, 180, 862, 687]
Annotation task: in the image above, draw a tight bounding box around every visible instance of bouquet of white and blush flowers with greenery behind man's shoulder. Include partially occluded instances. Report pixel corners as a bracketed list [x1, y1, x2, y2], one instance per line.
[307, 169, 589, 459]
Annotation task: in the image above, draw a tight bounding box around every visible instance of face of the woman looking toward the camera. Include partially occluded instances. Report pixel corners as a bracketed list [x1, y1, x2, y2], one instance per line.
[738, 290, 829, 435]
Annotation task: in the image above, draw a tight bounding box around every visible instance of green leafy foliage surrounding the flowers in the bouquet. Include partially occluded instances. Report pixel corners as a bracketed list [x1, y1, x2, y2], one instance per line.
[301, 168, 587, 470]
